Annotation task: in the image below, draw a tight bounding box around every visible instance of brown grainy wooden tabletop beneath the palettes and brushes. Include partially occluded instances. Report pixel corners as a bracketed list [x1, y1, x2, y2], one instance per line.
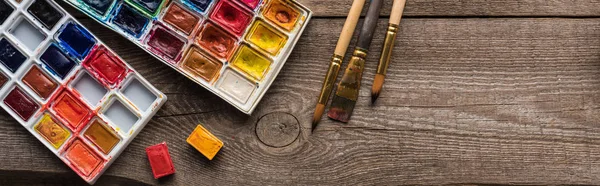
[0, 0, 600, 185]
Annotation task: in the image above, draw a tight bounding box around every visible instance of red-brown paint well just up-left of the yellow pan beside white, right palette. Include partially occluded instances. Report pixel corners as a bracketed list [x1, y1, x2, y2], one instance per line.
[196, 22, 237, 59]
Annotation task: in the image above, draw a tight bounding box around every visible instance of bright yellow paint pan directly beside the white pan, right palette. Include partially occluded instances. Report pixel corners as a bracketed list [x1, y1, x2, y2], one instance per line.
[231, 45, 271, 80]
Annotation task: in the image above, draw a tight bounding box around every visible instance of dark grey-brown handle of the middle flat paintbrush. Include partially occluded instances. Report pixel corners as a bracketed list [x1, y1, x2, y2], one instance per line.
[356, 0, 383, 50]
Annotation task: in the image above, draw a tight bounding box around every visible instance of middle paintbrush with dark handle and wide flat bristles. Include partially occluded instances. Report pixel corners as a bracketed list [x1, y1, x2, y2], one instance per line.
[327, 0, 383, 122]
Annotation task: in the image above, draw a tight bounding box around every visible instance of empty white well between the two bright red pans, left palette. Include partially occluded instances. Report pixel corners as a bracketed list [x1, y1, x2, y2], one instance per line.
[73, 73, 107, 107]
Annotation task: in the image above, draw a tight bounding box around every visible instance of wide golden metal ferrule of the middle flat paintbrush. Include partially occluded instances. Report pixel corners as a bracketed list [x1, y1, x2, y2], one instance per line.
[336, 48, 367, 100]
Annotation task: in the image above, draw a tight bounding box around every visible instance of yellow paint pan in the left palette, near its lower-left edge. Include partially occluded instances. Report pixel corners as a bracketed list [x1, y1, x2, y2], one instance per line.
[33, 114, 71, 149]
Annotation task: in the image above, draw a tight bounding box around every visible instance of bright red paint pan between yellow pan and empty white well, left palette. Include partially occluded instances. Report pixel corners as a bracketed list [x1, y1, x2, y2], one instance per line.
[52, 90, 92, 131]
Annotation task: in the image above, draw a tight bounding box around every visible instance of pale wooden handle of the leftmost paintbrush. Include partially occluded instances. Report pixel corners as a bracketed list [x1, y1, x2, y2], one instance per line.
[335, 0, 365, 56]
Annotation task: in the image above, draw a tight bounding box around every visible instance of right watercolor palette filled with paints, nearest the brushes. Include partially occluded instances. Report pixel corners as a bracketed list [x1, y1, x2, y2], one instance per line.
[65, 0, 312, 114]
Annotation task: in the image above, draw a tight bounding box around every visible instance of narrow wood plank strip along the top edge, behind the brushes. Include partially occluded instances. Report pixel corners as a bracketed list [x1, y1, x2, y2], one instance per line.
[57, 0, 600, 18]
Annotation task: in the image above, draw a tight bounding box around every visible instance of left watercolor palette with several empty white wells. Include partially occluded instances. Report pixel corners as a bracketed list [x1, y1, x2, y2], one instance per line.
[0, 0, 167, 184]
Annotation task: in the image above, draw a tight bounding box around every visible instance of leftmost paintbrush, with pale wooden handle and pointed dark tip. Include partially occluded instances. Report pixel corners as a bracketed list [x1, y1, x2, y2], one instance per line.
[312, 0, 365, 130]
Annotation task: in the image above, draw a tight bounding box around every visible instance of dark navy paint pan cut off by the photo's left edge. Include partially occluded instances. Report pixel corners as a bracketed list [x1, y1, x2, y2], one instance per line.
[0, 38, 27, 73]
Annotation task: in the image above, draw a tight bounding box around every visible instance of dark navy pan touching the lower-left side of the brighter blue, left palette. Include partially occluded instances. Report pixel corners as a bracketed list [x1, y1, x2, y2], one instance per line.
[40, 43, 77, 79]
